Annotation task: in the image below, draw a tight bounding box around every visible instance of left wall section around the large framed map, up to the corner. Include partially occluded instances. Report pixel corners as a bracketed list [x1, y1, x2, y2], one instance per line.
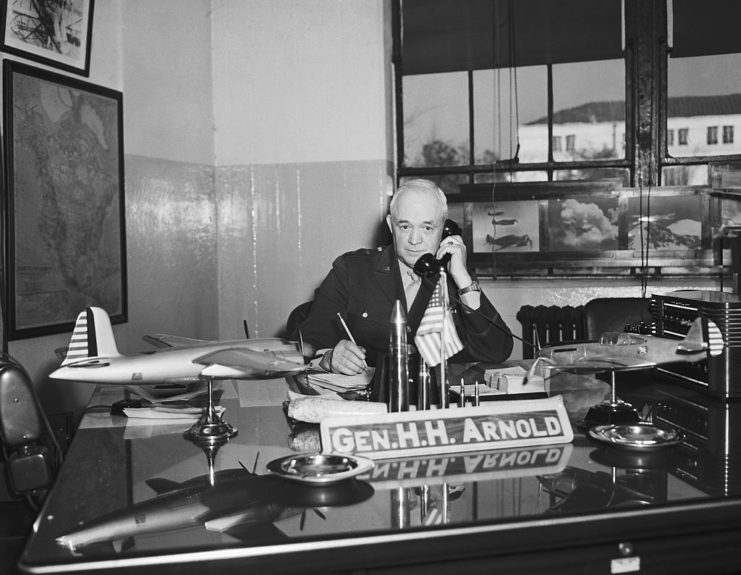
[8, 0, 218, 412]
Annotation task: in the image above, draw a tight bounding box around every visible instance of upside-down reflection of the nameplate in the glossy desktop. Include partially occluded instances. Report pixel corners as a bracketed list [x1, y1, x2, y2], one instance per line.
[361, 443, 573, 489]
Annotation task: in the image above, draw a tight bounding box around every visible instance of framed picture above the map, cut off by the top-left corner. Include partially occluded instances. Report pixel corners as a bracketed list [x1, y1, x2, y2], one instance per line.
[0, 0, 95, 76]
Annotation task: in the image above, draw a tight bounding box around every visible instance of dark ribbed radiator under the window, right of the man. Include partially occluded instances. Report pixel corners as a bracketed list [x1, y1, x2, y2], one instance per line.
[516, 305, 585, 359]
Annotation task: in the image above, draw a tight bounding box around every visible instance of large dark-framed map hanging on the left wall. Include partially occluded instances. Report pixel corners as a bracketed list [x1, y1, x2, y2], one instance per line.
[3, 60, 127, 340]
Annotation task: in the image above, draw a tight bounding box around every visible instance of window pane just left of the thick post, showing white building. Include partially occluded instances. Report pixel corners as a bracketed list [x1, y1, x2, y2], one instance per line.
[553, 59, 625, 161]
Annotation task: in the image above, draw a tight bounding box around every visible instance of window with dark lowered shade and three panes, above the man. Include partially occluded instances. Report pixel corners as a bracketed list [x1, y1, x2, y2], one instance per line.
[394, 0, 630, 193]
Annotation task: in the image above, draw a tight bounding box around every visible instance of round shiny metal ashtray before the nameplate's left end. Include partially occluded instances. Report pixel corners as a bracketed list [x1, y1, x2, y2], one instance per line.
[268, 453, 374, 485]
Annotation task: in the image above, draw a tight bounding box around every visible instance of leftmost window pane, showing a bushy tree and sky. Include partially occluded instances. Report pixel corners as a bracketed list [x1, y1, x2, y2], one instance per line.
[402, 72, 469, 167]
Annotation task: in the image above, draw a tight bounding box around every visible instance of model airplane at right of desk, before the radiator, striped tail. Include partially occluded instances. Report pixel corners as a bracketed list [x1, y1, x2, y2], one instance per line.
[529, 318, 724, 375]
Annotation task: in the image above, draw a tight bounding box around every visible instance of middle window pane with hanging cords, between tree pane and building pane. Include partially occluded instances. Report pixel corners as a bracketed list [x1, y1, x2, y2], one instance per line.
[473, 66, 548, 164]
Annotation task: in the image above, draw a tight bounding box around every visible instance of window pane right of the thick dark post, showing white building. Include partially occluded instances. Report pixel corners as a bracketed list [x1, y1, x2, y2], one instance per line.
[666, 54, 741, 158]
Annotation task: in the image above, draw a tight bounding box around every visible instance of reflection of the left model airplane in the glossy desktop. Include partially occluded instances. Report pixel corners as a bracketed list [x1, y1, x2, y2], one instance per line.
[56, 467, 373, 553]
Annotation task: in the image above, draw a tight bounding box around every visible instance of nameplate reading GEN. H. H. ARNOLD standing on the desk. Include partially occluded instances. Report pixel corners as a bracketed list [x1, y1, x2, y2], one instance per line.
[320, 395, 574, 459]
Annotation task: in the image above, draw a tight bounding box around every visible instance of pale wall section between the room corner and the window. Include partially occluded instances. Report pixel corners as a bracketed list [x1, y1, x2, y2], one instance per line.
[213, 0, 393, 338]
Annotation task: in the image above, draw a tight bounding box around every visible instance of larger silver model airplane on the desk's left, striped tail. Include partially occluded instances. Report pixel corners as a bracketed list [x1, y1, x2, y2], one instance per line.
[49, 307, 308, 386]
